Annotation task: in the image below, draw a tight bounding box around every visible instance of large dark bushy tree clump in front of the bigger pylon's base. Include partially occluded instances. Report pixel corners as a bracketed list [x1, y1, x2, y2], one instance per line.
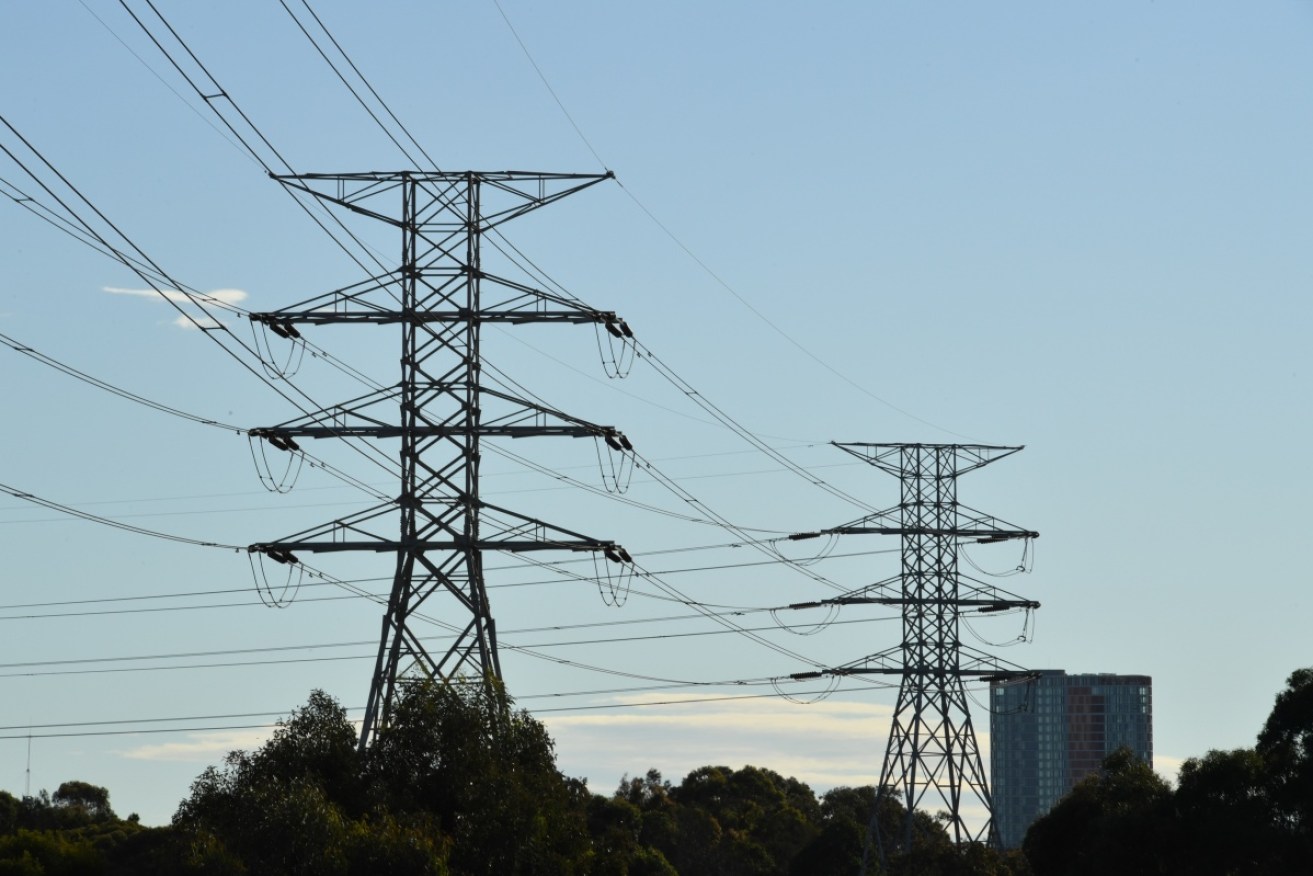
[173, 682, 601, 876]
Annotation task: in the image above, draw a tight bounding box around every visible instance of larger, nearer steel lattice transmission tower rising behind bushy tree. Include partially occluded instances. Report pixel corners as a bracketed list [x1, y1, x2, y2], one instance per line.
[249, 171, 632, 749]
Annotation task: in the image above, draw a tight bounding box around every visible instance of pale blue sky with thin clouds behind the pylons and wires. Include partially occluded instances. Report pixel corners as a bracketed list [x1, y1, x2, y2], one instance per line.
[0, 0, 1313, 822]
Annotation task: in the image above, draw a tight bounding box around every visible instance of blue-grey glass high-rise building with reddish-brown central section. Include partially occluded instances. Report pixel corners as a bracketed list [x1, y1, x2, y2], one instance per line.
[989, 670, 1153, 848]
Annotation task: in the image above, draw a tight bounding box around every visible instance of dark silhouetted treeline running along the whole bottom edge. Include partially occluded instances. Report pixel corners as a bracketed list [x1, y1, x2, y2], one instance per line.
[0, 670, 1313, 876]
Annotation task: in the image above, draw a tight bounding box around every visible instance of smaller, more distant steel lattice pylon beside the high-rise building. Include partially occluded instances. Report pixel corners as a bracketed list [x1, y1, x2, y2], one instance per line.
[794, 444, 1039, 872]
